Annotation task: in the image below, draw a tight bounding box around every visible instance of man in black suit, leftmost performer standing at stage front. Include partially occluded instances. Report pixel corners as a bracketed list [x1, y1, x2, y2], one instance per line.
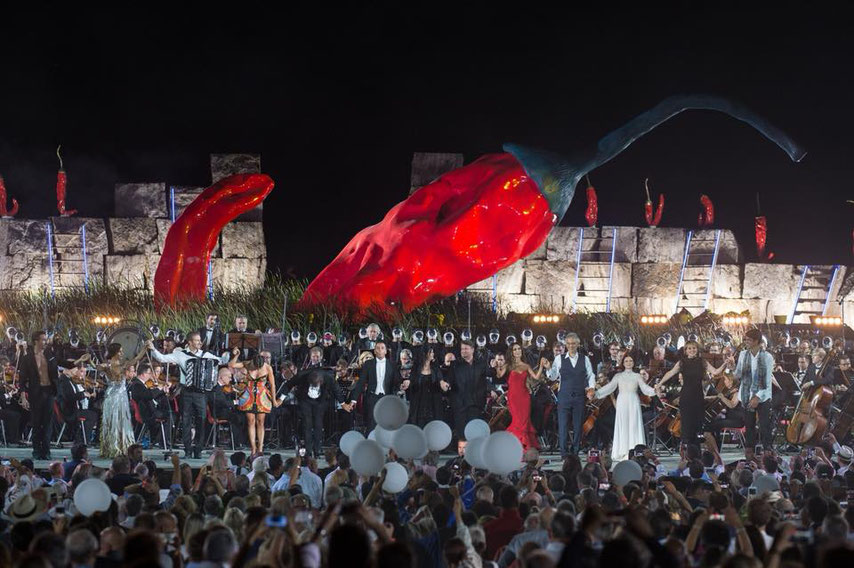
[18, 331, 59, 460]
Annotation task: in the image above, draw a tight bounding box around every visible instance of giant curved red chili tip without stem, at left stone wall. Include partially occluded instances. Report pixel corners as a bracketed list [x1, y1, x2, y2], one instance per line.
[154, 174, 273, 308]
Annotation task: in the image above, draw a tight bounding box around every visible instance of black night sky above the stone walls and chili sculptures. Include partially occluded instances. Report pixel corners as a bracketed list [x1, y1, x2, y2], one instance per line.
[0, 2, 854, 278]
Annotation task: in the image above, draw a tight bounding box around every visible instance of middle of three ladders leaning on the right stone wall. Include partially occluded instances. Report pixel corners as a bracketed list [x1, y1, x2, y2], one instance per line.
[673, 229, 723, 315]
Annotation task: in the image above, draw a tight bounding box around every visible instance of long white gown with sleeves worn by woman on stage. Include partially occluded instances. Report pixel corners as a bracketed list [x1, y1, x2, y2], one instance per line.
[596, 371, 655, 464]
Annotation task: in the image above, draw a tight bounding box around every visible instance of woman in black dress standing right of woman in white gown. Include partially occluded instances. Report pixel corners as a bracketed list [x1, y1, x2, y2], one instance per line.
[655, 341, 729, 444]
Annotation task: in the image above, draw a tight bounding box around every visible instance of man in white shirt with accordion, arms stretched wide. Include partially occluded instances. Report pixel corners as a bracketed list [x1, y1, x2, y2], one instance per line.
[146, 331, 230, 459]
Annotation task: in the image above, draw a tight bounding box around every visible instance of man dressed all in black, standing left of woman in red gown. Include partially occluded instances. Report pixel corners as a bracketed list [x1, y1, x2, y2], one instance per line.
[439, 339, 495, 440]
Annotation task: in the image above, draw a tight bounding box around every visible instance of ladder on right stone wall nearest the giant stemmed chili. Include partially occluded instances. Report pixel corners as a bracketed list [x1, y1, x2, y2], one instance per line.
[572, 227, 618, 314]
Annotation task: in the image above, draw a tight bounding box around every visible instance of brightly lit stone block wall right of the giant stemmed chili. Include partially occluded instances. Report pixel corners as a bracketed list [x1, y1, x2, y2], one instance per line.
[469, 227, 854, 325]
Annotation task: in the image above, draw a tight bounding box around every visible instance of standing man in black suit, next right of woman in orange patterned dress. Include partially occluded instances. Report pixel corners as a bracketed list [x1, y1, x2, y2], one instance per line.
[285, 346, 353, 458]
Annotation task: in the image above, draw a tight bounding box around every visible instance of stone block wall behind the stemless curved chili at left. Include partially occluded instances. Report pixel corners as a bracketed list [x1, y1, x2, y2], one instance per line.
[0, 154, 267, 290]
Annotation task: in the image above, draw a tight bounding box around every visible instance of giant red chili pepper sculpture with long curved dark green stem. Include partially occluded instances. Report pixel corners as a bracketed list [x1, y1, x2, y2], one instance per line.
[303, 96, 804, 309]
